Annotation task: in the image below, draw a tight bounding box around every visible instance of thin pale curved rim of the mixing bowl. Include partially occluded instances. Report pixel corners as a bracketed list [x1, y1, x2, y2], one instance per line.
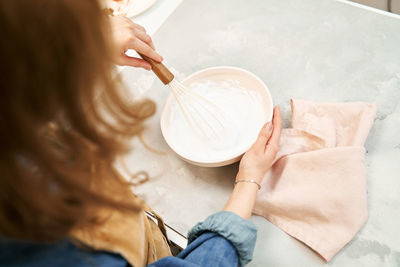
[160, 66, 273, 167]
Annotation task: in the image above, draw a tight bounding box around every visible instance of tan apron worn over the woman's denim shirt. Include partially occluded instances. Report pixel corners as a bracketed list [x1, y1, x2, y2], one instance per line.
[70, 202, 171, 267]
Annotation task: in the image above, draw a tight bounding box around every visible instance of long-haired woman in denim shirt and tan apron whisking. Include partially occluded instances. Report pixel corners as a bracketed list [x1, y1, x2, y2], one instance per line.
[0, 0, 281, 266]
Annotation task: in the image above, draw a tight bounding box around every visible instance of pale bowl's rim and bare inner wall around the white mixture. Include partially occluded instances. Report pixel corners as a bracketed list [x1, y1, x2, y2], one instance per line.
[160, 66, 273, 167]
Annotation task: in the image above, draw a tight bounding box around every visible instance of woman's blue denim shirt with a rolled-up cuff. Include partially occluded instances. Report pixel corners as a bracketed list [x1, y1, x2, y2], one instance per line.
[0, 212, 257, 267]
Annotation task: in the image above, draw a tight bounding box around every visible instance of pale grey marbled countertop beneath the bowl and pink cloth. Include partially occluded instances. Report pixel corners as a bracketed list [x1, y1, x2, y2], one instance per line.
[121, 0, 400, 267]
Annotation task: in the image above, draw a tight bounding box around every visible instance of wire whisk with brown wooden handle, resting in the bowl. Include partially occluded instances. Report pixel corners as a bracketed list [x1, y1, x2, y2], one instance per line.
[139, 53, 226, 139]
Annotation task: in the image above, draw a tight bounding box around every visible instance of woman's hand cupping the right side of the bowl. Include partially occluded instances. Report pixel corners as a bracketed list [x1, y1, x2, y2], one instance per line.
[236, 107, 282, 184]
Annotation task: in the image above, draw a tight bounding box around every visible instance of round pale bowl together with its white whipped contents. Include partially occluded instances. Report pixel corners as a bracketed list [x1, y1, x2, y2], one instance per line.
[161, 67, 273, 167]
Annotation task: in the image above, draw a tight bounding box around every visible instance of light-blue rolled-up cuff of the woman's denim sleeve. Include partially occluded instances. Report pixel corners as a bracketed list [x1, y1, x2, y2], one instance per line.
[188, 211, 257, 266]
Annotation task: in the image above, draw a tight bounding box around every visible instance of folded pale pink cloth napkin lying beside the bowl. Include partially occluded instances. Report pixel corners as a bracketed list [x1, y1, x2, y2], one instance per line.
[254, 100, 376, 261]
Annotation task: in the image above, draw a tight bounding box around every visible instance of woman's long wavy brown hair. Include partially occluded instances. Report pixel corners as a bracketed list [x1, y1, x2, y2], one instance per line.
[0, 0, 155, 240]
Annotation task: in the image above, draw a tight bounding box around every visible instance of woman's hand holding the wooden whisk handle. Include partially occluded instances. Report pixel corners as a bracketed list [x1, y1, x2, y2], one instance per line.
[110, 16, 163, 70]
